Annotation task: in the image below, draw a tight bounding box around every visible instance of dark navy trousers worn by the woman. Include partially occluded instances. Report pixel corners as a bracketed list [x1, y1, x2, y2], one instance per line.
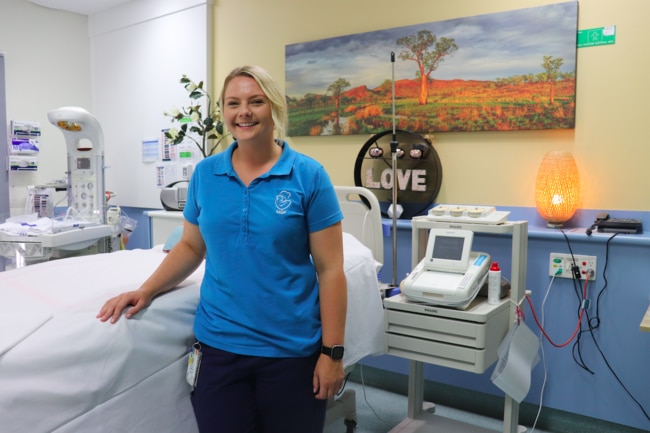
[192, 343, 327, 433]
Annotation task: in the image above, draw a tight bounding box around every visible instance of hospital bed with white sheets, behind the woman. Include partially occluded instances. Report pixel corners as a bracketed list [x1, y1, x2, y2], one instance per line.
[0, 187, 384, 433]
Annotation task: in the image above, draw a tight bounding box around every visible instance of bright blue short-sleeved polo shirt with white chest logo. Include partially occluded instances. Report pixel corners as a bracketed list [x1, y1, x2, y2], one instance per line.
[183, 142, 343, 357]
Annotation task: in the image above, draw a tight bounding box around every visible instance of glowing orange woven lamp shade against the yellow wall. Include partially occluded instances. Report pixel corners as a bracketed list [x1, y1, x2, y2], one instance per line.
[535, 151, 580, 228]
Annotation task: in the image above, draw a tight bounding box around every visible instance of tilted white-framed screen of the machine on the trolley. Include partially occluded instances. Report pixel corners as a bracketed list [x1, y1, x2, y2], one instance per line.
[425, 229, 474, 273]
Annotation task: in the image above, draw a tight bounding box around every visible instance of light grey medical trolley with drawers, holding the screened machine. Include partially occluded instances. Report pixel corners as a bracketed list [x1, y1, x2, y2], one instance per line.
[384, 216, 528, 433]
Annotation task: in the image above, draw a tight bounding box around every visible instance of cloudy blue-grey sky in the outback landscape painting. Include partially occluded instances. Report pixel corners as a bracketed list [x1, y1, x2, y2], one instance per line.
[285, 2, 578, 97]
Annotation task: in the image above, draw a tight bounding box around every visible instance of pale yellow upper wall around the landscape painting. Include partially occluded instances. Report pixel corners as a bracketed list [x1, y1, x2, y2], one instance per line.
[214, 0, 650, 210]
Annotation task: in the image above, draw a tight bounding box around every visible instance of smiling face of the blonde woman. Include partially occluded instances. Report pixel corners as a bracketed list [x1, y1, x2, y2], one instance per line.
[223, 76, 274, 144]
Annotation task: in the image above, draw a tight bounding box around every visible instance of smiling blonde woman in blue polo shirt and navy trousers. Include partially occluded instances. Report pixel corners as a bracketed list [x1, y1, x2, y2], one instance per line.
[97, 66, 347, 433]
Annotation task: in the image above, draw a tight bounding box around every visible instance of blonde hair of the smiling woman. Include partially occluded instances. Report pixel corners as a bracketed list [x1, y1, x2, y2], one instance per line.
[219, 66, 288, 140]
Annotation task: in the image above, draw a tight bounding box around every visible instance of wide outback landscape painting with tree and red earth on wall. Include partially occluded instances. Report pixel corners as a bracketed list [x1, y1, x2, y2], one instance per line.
[285, 2, 578, 136]
